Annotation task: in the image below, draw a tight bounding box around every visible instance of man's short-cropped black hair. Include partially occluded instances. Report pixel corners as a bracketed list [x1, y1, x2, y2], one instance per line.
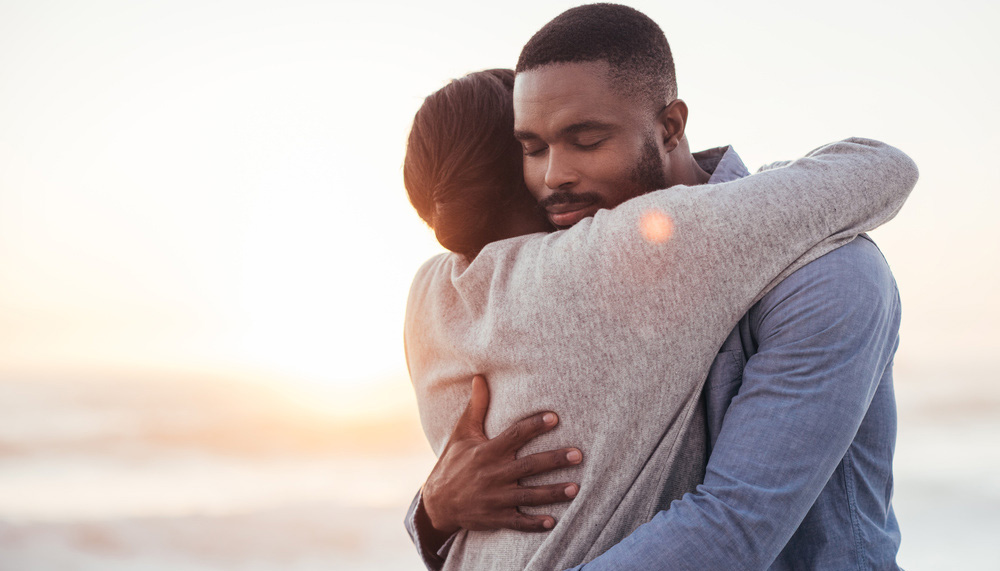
[517, 4, 677, 104]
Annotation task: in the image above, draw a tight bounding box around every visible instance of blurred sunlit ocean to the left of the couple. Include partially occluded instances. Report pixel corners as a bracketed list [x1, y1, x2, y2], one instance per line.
[0, 379, 433, 571]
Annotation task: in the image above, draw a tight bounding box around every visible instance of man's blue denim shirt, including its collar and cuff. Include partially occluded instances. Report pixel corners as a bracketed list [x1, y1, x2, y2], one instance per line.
[406, 147, 900, 571]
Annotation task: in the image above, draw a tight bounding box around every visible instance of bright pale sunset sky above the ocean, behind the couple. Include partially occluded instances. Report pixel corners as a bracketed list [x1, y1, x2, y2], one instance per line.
[0, 0, 1000, 412]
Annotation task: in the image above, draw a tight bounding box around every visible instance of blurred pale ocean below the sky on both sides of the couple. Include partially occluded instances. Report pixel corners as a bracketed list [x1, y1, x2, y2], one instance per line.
[0, 366, 1000, 571]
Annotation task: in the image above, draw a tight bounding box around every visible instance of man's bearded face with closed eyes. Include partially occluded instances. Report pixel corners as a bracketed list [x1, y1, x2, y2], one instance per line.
[514, 61, 669, 228]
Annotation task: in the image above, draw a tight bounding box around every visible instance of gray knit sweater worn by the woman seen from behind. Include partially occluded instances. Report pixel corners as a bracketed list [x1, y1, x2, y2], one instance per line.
[404, 139, 917, 570]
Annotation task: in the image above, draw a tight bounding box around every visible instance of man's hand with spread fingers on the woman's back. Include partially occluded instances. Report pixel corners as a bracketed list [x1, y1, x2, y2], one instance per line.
[422, 375, 583, 536]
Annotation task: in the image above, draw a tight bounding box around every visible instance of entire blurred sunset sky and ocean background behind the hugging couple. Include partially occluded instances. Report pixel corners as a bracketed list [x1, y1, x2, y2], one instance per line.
[0, 0, 1000, 571]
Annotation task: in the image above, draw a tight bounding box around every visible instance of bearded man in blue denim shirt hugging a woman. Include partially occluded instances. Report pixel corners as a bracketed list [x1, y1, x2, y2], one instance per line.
[404, 5, 916, 569]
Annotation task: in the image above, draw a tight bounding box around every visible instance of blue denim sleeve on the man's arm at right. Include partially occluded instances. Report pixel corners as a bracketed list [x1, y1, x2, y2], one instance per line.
[576, 238, 899, 571]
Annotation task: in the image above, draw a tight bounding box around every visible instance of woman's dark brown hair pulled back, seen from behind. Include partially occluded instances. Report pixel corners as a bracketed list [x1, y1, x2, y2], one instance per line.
[403, 69, 528, 257]
